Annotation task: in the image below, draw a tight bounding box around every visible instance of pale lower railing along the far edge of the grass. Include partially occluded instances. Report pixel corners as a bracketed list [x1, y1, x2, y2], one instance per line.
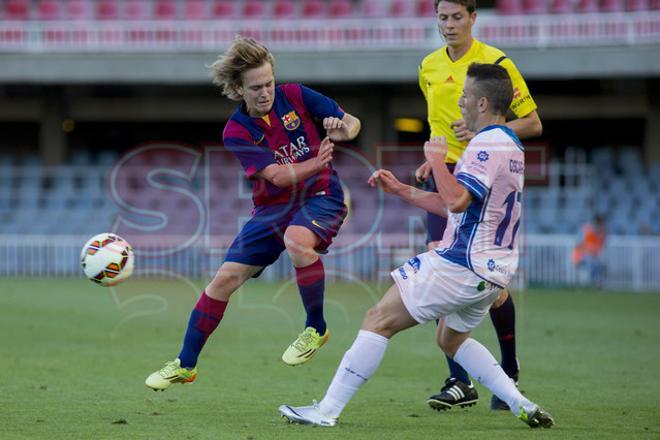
[0, 234, 660, 291]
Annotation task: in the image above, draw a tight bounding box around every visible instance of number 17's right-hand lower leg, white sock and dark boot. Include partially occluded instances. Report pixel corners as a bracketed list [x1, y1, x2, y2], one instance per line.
[438, 322, 555, 428]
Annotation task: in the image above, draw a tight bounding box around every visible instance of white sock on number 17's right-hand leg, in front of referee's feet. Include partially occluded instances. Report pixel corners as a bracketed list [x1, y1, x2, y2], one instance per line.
[454, 338, 534, 416]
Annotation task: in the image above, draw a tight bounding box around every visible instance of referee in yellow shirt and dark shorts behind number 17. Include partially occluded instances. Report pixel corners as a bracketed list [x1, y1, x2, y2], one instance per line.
[415, 0, 542, 410]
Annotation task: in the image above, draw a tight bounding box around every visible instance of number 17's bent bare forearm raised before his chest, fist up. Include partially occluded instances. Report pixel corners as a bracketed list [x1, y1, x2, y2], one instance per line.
[424, 136, 472, 213]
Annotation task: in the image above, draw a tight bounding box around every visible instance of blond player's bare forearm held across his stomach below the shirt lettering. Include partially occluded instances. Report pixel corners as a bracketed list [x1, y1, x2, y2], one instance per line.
[254, 137, 335, 188]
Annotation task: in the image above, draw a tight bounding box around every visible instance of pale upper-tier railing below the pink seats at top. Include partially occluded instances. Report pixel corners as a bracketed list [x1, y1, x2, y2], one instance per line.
[0, 10, 660, 53]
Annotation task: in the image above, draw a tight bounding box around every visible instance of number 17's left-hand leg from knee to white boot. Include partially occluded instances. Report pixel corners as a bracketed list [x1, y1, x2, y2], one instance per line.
[279, 285, 417, 426]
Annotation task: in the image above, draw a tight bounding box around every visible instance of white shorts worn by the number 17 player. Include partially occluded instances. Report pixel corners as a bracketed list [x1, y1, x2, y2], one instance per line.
[391, 251, 502, 332]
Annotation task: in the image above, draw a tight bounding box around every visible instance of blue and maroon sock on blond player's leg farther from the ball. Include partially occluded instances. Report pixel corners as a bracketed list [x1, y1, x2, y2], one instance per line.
[296, 258, 326, 336]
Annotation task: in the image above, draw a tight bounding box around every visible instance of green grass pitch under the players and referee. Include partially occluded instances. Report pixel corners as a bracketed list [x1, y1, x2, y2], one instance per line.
[0, 279, 660, 440]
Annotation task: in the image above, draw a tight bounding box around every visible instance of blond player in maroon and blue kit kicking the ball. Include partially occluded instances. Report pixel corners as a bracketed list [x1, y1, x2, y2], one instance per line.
[146, 37, 360, 390]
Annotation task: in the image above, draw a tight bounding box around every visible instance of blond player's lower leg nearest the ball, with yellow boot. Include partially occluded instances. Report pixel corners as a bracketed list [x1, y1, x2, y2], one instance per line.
[145, 262, 261, 391]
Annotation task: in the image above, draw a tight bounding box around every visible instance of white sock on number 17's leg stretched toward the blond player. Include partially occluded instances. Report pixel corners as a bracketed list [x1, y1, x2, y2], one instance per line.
[319, 330, 389, 417]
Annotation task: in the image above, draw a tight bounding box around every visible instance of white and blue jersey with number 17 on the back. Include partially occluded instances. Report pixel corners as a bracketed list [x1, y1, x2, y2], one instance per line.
[435, 125, 525, 287]
